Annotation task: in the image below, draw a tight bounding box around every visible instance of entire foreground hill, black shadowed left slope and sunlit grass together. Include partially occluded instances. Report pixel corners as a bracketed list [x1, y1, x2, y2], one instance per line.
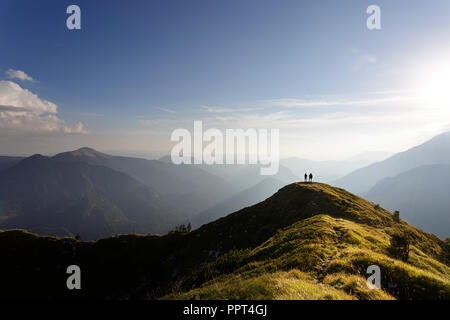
[0, 183, 450, 299]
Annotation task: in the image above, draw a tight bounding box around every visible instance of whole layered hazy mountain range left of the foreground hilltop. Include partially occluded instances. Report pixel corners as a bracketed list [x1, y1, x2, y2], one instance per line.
[0, 147, 297, 239]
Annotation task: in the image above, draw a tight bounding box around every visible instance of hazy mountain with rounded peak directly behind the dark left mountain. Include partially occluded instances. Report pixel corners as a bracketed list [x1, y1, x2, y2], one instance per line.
[53, 148, 234, 219]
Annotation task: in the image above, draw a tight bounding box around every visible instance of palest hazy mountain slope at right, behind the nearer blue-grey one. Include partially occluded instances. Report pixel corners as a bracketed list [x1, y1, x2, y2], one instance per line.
[333, 132, 450, 193]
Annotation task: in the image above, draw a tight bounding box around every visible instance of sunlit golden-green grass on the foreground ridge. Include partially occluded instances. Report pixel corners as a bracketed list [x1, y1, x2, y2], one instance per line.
[168, 215, 450, 299]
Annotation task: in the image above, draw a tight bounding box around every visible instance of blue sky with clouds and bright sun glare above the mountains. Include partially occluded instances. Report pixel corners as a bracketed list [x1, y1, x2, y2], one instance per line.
[0, 0, 450, 160]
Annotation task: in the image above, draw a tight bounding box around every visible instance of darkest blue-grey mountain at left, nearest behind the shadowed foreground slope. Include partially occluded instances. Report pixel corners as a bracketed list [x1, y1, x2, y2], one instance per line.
[0, 155, 184, 239]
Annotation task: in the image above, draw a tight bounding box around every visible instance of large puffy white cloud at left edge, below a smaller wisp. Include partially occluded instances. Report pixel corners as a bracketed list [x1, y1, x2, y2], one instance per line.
[0, 81, 88, 133]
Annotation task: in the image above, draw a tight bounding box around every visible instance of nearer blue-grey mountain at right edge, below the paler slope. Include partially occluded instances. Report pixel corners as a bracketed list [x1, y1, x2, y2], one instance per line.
[366, 165, 450, 238]
